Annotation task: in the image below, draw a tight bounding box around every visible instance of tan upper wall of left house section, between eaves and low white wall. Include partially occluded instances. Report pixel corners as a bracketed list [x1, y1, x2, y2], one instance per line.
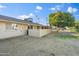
[0, 19, 28, 30]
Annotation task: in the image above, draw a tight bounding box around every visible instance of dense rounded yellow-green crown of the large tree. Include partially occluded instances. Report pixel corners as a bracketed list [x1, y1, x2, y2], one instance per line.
[49, 12, 75, 27]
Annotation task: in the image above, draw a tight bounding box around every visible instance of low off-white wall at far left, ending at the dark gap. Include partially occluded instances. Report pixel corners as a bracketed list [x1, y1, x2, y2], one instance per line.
[0, 30, 26, 40]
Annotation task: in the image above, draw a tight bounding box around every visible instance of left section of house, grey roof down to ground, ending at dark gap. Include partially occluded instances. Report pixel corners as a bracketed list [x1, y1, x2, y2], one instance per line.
[0, 15, 28, 39]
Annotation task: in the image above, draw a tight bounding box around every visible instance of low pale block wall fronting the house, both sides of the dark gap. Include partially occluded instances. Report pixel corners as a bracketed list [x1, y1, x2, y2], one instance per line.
[0, 29, 51, 39]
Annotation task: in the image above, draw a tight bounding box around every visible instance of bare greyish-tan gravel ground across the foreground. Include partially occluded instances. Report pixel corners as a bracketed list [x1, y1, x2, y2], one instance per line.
[0, 33, 79, 56]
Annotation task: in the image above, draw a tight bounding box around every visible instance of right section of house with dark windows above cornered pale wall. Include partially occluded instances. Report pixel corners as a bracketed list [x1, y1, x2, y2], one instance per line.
[29, 23, 51, 37]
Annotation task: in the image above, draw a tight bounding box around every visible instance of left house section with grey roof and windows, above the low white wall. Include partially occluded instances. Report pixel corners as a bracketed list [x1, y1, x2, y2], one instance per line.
[0, 15, 28, 31]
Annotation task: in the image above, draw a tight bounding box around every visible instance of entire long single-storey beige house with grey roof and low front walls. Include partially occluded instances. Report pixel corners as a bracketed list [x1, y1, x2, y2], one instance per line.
[0, 15, 51, 38]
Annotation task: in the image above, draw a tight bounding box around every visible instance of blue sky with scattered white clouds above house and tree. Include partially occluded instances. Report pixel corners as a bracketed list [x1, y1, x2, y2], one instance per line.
[0, 3, 79, 25]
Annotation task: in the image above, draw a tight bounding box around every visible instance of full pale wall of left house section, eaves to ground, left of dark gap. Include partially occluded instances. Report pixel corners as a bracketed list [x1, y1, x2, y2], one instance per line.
[0, 21, 28, 39]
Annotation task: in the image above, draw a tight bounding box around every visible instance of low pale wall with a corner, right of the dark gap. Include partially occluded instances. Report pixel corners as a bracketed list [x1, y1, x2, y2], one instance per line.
[29, 29, 51, 37]
